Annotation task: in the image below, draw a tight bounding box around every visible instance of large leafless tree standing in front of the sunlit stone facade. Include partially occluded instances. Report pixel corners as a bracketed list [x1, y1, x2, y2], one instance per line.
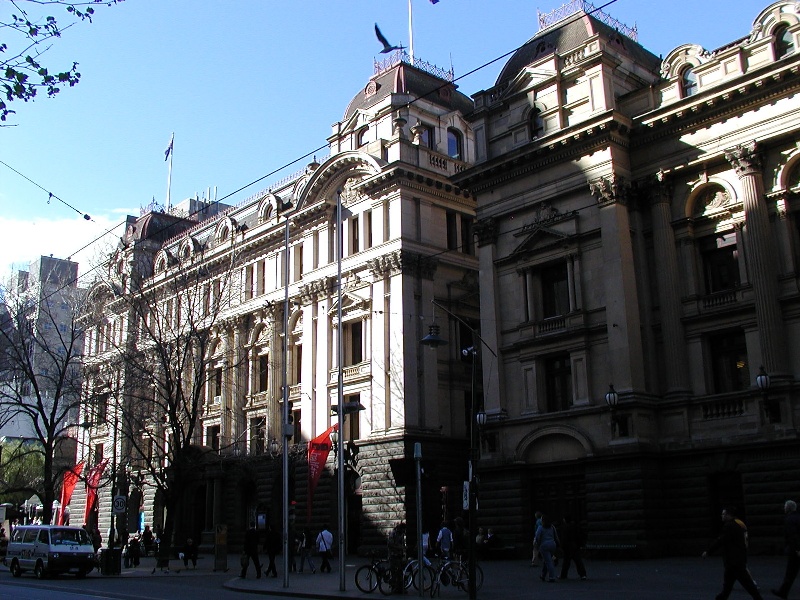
[87, 244, 239, 564]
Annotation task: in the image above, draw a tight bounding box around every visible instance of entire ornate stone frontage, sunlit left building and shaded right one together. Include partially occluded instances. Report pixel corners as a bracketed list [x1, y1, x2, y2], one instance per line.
[73, 0, 800, 554]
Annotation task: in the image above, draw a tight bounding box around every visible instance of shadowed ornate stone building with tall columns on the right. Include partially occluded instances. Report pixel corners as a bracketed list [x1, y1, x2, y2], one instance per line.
[451, 0, 800, 553]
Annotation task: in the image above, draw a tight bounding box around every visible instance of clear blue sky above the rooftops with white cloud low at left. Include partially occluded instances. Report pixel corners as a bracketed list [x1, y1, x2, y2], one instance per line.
[0, 0, 770, 279]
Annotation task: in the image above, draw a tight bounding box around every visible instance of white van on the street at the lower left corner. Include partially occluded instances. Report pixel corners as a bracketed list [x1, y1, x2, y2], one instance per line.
[5, 525, 96, 579]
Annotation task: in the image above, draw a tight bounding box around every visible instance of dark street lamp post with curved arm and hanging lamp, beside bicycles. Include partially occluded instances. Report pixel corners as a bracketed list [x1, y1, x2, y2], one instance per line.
[420, 300, 497, 600]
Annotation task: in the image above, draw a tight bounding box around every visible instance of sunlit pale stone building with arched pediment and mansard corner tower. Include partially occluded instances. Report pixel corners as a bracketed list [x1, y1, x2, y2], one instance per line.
[73, 55, 478, 551]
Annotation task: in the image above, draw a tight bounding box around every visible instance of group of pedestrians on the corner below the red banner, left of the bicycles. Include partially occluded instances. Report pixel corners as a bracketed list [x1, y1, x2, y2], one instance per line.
[239, 522, 333, 579]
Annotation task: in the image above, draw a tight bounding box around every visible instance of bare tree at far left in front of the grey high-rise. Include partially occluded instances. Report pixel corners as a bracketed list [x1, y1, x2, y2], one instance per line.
[0, 258, 84, 522]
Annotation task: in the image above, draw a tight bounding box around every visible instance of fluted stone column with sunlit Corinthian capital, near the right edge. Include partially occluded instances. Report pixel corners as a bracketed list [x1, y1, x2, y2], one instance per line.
[725, 142, 787, 375]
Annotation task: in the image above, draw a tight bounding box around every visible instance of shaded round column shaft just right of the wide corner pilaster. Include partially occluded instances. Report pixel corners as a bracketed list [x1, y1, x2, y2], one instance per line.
[652, 181, 689, 394]
